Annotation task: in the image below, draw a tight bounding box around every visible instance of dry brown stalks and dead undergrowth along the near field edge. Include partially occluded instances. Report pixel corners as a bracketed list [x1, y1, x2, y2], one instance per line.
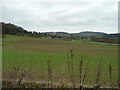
[2, 48, 118, 90]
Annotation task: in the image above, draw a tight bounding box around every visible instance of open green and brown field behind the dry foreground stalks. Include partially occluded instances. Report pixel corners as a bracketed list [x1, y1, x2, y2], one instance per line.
[2, 35, 118, 86]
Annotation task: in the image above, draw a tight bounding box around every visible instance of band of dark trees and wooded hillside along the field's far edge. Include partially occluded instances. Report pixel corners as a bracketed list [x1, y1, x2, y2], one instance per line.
[0, 22, 120, 44]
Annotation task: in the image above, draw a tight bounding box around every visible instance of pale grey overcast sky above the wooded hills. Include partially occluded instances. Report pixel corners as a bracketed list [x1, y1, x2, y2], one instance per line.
[0, 2, 118, 33]
